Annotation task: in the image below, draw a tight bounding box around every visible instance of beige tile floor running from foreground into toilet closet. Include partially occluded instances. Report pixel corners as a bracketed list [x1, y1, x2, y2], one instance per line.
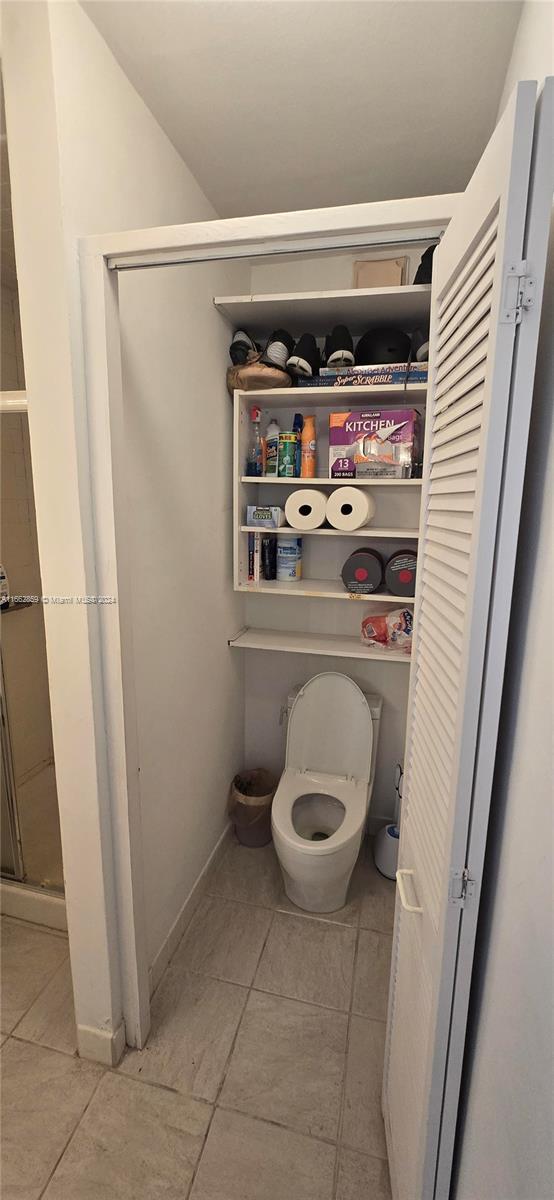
[0, 842, 395, 1200]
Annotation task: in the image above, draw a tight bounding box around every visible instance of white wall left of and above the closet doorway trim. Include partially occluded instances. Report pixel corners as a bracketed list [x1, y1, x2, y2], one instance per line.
[2, 0, 213, 1058]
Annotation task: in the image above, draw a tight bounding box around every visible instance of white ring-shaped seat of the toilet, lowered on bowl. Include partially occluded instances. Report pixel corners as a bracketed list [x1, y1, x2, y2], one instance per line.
[271, 768, 367, 857]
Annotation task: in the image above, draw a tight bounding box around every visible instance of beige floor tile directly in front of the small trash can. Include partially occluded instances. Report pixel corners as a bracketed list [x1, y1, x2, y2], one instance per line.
[209, 841, 282, 908]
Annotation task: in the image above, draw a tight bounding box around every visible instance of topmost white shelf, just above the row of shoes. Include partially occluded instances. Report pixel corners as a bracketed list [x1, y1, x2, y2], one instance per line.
[213, 284, 430, 337]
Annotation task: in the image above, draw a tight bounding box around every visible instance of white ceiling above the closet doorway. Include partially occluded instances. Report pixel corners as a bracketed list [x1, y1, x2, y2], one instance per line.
[83, 0, 520, 216]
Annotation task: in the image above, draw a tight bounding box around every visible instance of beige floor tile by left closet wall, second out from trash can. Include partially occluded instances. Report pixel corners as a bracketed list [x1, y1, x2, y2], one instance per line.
[174, 896, 272, 986]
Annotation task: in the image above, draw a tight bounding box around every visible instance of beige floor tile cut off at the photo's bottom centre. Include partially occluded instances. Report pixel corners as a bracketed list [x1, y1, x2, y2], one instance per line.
[191, 1109, 335, 1200]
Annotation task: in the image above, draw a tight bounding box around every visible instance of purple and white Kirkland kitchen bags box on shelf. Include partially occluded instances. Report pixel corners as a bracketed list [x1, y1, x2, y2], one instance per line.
[329, 408, 421, 479]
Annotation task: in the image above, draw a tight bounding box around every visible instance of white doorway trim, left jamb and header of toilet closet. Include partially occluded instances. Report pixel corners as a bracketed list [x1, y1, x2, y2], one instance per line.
[77, 193, 458, 1046]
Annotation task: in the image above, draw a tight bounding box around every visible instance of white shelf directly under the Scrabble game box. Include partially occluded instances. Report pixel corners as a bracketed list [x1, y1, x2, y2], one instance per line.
[239, 383, 427, 412]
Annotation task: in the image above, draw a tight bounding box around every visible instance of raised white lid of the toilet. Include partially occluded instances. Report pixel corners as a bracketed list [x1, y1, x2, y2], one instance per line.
[287, 671, 373, 781]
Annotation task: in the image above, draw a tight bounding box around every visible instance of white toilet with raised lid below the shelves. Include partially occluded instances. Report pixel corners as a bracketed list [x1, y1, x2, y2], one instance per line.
[271, 671, 383, 912]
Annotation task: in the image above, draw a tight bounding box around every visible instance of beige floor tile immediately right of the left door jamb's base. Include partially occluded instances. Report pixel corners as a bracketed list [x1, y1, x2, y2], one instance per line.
[120, 962, 248, 1100]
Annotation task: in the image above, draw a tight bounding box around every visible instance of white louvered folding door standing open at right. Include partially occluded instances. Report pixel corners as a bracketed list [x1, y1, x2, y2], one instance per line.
[383, 83, 551, 1200]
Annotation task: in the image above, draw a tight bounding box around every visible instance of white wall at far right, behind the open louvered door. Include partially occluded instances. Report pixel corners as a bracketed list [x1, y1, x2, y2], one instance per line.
[453, 4, 554, 1200]
